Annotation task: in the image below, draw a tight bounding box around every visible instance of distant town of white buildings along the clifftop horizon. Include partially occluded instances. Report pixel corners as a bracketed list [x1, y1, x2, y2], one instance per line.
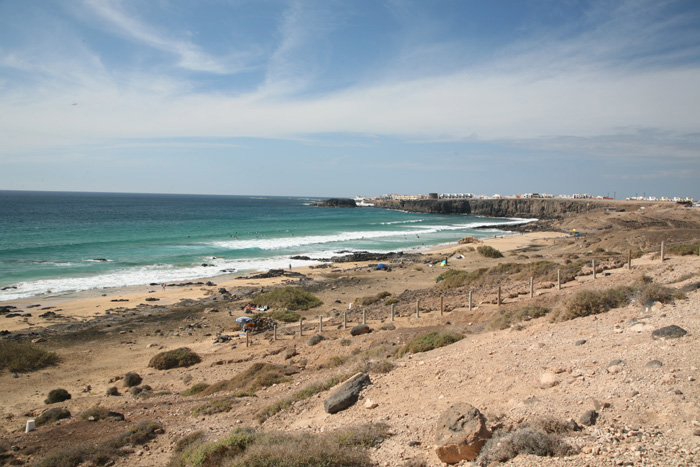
[354, 193, 700, 207]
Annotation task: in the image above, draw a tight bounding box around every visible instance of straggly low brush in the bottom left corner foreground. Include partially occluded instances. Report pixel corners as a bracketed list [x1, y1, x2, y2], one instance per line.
[36, 421, 163, 467]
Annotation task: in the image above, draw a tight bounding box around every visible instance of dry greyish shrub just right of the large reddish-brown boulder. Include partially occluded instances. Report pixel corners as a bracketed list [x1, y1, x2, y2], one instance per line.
[477, 427, 575, 467]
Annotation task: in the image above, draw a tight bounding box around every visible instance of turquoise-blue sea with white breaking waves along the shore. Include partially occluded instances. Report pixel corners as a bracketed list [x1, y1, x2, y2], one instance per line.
[0, 191, 523, 302]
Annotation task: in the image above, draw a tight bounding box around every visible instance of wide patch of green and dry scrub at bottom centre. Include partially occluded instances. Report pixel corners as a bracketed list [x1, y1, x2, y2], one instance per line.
[169, 424, 389, 467]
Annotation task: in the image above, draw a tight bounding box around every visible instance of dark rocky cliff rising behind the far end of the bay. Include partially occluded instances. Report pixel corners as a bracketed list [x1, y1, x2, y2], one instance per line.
[376, 198, 645, 219]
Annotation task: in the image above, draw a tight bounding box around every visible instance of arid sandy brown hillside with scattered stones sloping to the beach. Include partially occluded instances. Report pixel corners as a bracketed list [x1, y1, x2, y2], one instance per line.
[0, 204, 700, 466]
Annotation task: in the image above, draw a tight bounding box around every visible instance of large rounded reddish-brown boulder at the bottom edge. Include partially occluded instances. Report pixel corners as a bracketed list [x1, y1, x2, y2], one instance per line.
[435, 403, 491, 464]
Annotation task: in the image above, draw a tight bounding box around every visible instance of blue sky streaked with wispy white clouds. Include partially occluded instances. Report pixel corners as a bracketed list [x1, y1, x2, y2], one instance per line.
[0, 0, 700, 199]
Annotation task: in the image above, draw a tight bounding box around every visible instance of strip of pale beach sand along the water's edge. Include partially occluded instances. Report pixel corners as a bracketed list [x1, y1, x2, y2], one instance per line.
[0, 232, 566, 332]
